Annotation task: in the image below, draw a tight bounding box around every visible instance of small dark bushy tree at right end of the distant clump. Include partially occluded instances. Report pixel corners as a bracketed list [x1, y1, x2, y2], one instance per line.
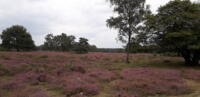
[75, 37, 90, 54]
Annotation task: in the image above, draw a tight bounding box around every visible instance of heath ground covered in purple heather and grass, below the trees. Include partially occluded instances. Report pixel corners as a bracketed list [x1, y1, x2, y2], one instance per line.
[0, 52, 200, 97]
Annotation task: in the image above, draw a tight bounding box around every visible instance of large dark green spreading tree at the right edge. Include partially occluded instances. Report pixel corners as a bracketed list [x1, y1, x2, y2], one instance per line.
[145, 0, 200, 65]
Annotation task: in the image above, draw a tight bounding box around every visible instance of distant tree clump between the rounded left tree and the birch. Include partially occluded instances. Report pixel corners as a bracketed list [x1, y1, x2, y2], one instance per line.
[39, 33, 96, 53]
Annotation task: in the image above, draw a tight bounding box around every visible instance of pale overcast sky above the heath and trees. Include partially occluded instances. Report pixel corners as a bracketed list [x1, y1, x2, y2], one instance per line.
[0, 0, 198, 48]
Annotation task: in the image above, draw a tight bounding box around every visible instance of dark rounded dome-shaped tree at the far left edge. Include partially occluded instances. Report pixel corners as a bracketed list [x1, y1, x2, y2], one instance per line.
[1, 25, 35, 51]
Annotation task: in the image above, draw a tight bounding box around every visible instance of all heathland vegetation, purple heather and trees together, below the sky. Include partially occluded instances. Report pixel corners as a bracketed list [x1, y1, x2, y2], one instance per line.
[0, 0, 200, 97]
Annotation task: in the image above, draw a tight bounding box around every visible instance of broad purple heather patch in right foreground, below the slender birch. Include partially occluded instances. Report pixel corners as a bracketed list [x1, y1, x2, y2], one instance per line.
[114, 68, 188, 96]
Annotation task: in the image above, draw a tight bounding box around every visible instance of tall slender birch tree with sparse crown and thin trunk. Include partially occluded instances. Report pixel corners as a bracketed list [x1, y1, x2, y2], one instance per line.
[107, 0, 149, 63]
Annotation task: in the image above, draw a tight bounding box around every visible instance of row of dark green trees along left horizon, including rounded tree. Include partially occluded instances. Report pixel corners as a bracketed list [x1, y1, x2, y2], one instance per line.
[0, 25, 97, 53]
